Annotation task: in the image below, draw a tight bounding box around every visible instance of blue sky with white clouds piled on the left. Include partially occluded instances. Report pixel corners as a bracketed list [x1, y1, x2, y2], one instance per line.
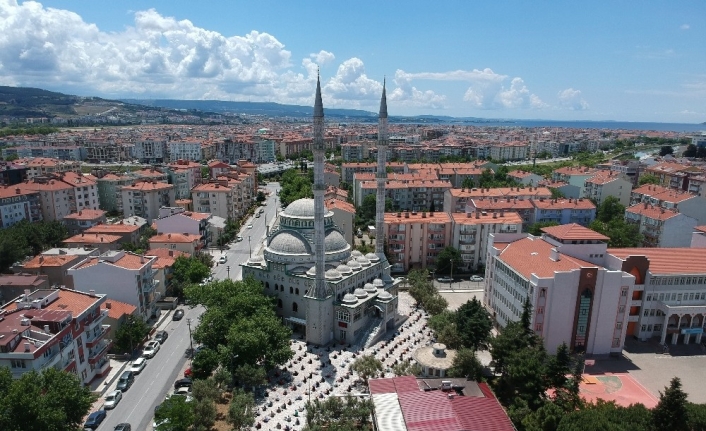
[0, 0, 706, 123]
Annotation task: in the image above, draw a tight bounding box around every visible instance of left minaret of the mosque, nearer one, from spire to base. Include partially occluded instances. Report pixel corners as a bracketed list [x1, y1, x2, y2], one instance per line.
[305, 72, 334, 346]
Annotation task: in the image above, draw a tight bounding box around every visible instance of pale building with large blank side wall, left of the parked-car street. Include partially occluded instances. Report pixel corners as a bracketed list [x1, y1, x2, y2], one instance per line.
[69, 251, 159, 321]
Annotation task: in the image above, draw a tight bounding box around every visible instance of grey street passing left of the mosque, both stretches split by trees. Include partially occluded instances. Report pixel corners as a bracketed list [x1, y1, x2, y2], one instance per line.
[98, 183, 279, 431]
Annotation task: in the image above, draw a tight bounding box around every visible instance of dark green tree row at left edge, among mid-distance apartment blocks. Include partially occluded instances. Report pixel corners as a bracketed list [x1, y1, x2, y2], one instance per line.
[0, 220, 68, 272]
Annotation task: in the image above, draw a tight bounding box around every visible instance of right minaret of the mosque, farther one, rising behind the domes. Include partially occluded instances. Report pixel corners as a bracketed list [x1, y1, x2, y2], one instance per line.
[375, 80, 389, 262]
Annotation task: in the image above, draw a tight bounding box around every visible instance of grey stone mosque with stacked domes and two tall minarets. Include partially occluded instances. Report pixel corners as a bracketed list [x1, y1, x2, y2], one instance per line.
[242, 79, 398, 345]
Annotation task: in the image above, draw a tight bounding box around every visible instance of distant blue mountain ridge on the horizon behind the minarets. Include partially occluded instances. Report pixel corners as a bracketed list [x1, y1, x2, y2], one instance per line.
[122, 99, 377, 121]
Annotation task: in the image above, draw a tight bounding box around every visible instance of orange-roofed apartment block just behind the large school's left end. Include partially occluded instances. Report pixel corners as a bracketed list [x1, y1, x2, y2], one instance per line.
[450, 211, 522, 272]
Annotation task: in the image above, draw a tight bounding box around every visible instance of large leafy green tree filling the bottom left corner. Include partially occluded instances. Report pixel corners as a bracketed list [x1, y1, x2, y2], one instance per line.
[0, 367, 96, 431]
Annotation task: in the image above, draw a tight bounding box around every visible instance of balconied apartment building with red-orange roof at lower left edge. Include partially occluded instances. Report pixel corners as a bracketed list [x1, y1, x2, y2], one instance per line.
[0, 288, 111, 385]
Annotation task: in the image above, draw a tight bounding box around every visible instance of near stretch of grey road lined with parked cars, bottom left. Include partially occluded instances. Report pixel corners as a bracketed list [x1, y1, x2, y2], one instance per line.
[98, 307, 203, 431]
